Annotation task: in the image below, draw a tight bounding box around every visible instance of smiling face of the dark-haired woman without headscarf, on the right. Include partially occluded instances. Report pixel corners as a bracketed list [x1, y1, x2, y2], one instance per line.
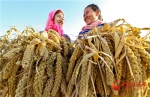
[83, 7, 99, 25]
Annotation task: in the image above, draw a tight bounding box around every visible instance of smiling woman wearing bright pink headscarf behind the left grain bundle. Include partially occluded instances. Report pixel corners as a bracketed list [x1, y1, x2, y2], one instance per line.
[45, 9, 71, 41]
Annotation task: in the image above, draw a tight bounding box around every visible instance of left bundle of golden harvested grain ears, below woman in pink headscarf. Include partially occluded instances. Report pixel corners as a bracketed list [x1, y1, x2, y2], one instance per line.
[0, 27, 71, 97]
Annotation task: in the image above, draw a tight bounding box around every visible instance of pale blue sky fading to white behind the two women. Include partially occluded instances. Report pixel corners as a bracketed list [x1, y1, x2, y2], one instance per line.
[0, 0, 150, 40]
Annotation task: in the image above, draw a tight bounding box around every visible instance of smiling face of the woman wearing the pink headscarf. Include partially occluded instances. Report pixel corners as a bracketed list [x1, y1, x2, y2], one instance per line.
[54, 12, 64, 26]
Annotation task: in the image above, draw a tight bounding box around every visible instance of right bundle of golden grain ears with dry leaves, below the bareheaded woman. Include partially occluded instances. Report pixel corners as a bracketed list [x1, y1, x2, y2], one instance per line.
[65, 19, 150, 97]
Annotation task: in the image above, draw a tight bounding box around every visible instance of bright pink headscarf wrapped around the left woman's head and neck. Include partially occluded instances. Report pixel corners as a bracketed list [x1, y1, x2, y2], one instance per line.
[45, 9, 64, 36]
